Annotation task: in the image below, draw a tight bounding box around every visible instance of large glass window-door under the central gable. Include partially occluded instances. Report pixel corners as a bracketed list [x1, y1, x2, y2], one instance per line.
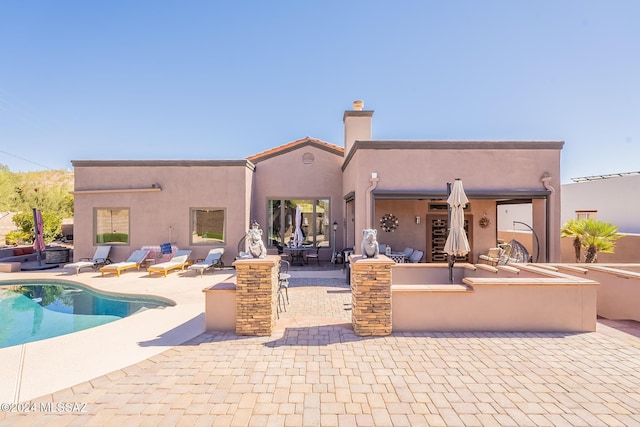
[267, 199, 332, 251]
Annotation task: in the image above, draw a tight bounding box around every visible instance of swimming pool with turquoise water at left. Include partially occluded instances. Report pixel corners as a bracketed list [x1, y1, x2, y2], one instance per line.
[0, 280, 173, 348]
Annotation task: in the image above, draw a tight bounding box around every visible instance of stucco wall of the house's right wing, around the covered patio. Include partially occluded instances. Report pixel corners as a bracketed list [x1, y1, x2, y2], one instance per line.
[343, 141, 562, 260]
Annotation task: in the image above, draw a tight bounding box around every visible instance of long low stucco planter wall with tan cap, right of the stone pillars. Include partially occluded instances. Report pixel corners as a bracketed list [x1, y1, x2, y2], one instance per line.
[391, 264, 598, 332]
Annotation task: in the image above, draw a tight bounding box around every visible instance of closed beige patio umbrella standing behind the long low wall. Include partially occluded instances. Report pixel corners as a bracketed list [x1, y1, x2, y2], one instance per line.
[444, 178, 470, 283]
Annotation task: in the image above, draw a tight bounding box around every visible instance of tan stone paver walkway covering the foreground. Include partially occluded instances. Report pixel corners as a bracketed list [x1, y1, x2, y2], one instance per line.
[0, 281, 640, 427]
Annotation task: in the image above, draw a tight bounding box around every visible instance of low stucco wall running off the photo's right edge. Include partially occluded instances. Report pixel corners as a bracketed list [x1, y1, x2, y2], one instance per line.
[554, 264, 640, 322]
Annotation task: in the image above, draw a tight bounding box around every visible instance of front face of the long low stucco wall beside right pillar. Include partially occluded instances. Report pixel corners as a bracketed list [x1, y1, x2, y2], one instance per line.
[392, 279, 597, 332]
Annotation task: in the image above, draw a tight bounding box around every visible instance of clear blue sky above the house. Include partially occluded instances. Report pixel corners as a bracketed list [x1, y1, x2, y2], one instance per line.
[0, 0, 640, 183]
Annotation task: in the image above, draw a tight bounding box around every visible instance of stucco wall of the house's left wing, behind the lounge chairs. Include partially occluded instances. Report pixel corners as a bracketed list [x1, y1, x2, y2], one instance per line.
[73, 161, 253, 264]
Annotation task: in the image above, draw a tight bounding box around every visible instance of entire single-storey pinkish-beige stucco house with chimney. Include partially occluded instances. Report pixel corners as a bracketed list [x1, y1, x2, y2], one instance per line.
[72, 102, 564, 264]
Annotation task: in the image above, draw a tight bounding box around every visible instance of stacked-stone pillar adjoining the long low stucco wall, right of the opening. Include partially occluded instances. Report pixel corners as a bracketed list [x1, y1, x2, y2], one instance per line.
[350, 255, 394, 337]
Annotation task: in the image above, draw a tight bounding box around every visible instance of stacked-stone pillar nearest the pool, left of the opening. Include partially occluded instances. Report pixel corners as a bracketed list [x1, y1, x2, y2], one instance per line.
[233, 255, 280, 336]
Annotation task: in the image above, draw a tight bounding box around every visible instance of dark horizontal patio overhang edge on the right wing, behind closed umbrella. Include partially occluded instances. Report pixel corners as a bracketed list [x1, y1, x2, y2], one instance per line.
[373, 188, 551, 201]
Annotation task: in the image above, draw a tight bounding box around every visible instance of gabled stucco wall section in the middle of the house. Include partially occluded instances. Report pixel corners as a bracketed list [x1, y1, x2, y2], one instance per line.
[251, 143, 343, 260]
